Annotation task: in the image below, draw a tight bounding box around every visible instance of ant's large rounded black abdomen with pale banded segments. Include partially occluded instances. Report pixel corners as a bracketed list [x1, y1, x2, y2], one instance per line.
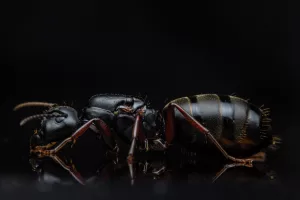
[171, 94, 270, 152]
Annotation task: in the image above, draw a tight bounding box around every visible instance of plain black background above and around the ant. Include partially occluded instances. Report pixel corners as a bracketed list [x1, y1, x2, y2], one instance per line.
[0, 0, 300, 198]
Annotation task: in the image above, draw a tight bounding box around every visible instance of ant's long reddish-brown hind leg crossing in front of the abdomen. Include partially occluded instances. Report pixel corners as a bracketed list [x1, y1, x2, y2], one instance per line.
[166, 103, 261, 167]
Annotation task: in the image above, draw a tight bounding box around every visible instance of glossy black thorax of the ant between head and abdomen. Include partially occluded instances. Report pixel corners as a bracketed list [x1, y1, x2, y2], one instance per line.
[83, 94, 163, 144]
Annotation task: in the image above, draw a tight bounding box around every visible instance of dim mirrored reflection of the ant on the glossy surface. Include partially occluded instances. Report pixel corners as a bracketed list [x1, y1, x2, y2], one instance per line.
[30, 141, 276, 185]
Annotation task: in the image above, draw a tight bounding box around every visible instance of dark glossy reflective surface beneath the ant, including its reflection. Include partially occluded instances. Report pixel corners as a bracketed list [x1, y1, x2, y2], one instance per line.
[0, 110, 297, 199]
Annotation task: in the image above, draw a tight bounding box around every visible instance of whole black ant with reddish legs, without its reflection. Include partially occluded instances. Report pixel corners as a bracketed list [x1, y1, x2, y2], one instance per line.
[15, 94, 280, 184]
